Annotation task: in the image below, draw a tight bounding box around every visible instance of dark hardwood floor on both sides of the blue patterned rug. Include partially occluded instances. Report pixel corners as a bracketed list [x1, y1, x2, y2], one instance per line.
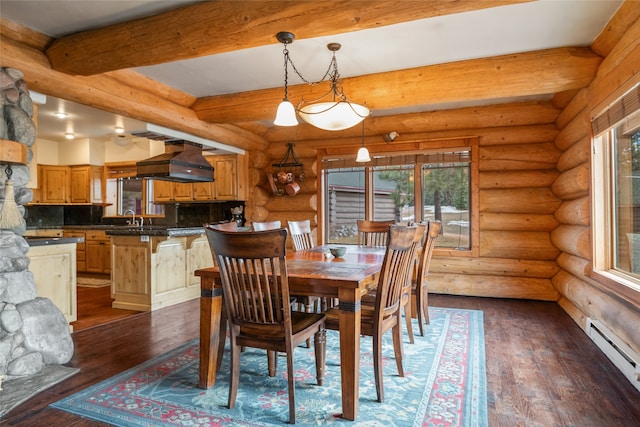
[0, 294, 640, 427]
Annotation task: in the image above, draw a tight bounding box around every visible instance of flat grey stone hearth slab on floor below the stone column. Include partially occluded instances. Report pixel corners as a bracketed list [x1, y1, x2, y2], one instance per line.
[0, 365, 80, 419]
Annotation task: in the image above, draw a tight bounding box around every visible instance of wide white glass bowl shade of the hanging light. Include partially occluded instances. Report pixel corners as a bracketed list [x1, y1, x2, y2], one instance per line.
[298, 101, 369, 131]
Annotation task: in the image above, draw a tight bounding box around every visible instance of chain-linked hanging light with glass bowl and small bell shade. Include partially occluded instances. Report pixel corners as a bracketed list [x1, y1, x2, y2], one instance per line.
[274, 32, 371, 131]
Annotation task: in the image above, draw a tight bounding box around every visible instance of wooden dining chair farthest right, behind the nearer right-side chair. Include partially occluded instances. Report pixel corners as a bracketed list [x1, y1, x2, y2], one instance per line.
[411, 221, 442, 336]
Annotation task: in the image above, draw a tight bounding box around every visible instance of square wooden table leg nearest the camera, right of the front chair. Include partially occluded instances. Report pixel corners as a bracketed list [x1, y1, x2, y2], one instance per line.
[339, 289, 361, 421]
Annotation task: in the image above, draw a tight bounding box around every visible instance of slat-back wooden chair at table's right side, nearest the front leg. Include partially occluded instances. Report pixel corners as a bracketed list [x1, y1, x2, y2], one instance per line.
[325, 225, 417, 402]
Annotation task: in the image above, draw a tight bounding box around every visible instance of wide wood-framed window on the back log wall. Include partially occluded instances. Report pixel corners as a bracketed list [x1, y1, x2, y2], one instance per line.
[323, 147, 477, 251]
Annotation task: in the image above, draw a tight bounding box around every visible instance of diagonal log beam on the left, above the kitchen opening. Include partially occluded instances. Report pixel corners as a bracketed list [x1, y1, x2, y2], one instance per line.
[0, 34, 267, 150]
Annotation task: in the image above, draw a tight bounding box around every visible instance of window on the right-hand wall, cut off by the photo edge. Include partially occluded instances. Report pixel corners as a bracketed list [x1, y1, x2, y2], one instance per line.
[592, 86, 640, 298]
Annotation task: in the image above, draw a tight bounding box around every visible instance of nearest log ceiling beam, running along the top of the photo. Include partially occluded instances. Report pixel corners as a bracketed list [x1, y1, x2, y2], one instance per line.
[46, 0, 531, 76]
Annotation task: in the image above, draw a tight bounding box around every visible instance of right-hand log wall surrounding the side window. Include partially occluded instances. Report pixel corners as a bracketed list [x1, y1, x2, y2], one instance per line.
[551, 13, 640, 360]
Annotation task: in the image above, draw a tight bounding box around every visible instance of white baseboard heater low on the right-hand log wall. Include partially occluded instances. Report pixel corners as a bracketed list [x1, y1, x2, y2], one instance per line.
[587, 319, 640, 391]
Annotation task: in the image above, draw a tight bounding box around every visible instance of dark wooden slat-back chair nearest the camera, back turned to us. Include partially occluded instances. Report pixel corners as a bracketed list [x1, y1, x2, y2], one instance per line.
[205, 227, 326, 424]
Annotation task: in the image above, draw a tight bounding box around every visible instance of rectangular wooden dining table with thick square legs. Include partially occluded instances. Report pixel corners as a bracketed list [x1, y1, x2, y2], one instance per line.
[195, 245, 385, 420]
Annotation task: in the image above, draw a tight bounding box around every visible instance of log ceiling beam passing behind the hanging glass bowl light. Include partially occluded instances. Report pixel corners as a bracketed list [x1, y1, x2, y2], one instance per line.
[193, 48, 602, 123]
